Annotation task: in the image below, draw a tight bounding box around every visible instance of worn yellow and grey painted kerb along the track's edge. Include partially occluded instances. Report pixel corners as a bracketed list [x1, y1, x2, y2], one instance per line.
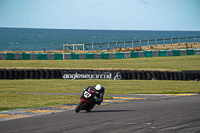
[0, 93, 199, 121]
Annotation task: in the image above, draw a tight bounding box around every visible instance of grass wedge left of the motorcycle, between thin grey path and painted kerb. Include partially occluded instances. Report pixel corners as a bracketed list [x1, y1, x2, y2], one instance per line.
[0, 93, 80, 111]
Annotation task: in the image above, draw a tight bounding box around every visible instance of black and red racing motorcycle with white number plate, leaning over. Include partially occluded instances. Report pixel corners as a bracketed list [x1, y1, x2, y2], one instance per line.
[75, 90, 97, 113]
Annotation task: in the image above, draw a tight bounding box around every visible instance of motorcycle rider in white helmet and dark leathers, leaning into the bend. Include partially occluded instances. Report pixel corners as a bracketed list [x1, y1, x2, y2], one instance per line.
[80, 84, 105, 105]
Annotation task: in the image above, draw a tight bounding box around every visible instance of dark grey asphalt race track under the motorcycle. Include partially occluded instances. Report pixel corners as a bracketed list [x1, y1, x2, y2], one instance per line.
[0, 95, 200, 133]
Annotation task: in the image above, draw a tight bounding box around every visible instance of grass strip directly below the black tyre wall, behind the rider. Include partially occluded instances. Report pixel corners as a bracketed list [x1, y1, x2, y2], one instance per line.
[0, 79, 200, 94]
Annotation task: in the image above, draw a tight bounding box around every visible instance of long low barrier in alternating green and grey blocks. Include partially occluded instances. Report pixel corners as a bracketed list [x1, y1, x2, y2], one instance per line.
[0, 49, 200, 60]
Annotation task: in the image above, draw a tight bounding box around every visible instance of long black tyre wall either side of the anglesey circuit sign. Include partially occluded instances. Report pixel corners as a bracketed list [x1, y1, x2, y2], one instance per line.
[0, 69, 200, 81]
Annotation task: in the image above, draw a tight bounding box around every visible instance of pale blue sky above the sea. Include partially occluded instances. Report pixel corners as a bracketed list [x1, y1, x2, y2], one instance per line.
[0, 0, 200, 31]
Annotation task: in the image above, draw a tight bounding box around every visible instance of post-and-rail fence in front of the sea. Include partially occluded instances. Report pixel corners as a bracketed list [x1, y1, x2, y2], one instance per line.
[63, 36, 200, 51]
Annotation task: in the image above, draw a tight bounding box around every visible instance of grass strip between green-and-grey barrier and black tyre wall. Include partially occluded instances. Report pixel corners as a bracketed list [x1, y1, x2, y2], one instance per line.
[0, 55, 200, 70]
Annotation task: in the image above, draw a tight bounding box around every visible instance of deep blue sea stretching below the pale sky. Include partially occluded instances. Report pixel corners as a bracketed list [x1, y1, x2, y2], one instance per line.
[0, 27, 200, 51]
